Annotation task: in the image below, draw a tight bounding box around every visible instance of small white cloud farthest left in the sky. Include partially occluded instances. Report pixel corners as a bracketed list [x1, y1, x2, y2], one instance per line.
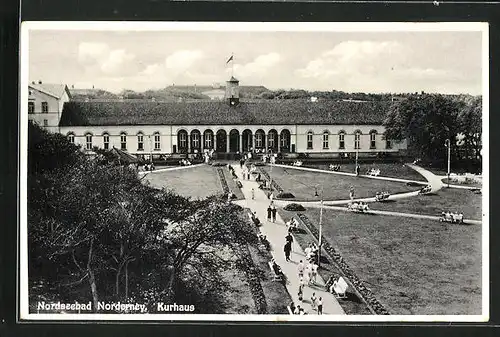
[78, 42, 135, 75]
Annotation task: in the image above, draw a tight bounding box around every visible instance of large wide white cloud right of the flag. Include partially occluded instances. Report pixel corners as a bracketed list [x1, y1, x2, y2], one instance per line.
[294, 41, 457, 91]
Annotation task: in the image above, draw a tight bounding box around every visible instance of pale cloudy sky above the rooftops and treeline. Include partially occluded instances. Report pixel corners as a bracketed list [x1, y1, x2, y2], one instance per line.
[28, 27, 482, 95]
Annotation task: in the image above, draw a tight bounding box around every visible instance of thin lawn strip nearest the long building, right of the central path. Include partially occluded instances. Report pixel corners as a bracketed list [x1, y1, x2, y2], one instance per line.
[303, 163, 427, 182]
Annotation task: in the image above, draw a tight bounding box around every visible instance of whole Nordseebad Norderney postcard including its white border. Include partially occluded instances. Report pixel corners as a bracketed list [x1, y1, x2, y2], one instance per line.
[18, 21, 489, 322]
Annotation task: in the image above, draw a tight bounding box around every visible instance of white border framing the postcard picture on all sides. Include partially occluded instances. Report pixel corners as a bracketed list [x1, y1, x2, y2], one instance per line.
[17, 21, 490, 322]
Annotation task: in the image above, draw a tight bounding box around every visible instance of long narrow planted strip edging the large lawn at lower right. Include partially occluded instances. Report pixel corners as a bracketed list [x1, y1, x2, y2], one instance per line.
[298, 214, 390, 315]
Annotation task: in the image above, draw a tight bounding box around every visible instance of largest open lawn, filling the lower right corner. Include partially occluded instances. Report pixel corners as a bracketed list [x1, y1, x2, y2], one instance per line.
[305, 209, 481, 315]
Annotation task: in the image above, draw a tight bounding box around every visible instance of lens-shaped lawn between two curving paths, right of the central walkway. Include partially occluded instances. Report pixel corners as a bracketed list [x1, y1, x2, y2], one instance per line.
[263, 166, 417, 201]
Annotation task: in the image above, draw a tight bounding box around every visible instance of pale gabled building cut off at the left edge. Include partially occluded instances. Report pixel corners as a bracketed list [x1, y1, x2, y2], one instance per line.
[28, 81, 71, 132]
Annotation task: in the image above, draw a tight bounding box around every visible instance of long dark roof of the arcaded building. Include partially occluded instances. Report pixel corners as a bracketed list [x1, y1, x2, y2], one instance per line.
[60, 100, 390, 126]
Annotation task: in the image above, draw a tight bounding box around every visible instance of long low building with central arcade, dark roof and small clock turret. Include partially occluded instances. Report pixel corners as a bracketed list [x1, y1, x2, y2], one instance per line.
[34, 77, 406, 157]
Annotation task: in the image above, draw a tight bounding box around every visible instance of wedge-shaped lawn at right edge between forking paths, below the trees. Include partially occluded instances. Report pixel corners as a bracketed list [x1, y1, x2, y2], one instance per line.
[370, 188, 482, 220]
